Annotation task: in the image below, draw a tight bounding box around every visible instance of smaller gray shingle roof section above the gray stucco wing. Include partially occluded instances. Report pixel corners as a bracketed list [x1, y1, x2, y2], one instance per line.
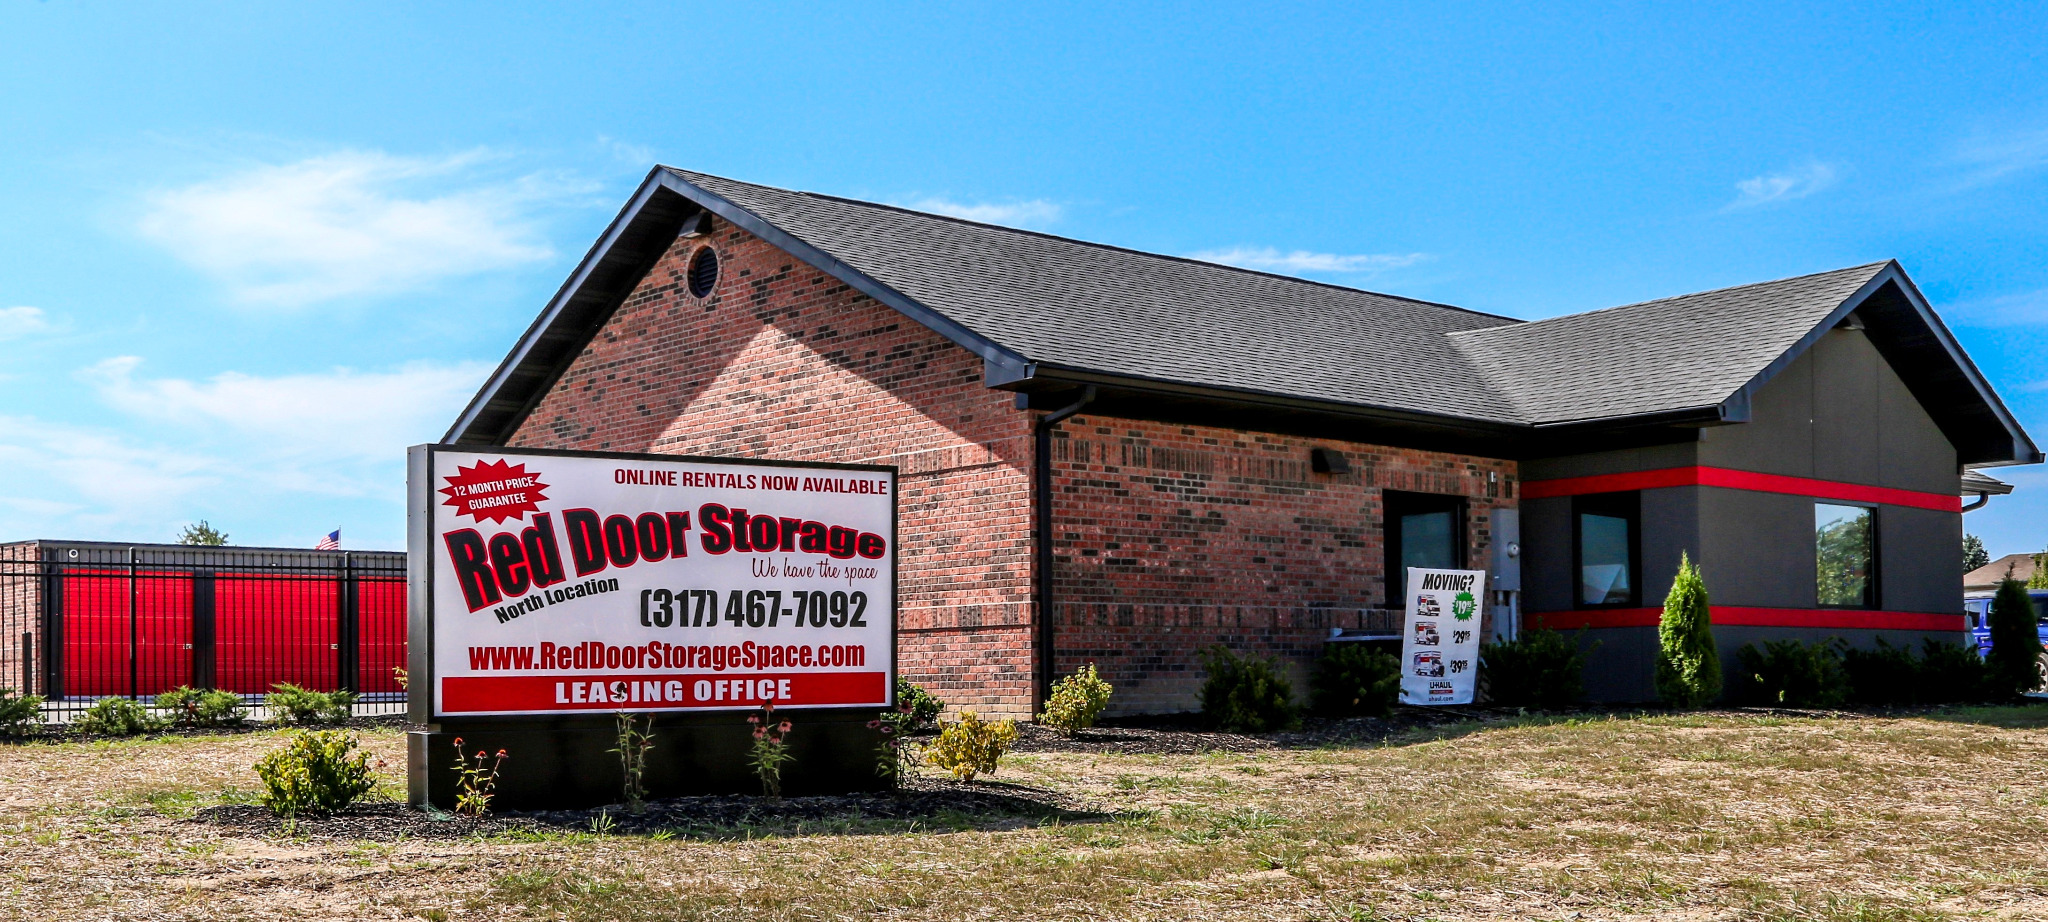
[1448, 262, 1886, 424]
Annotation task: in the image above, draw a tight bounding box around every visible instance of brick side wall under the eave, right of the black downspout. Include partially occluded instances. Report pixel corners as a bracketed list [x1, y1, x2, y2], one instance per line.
[1053, 416, 1516, 713]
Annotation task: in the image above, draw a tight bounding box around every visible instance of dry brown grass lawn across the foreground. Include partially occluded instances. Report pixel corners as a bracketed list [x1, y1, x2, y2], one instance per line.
[0, 709, 2048, 922]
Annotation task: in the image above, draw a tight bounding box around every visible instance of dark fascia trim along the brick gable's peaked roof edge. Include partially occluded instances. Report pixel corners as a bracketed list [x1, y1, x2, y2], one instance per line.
[442, 166, 1030, 445]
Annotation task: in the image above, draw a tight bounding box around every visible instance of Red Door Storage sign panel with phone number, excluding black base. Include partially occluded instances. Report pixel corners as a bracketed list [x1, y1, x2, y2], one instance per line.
[412, 447, 897, 717]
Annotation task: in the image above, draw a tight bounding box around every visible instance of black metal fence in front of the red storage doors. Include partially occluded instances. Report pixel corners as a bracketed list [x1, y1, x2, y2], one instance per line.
[0, 541, 406, 721]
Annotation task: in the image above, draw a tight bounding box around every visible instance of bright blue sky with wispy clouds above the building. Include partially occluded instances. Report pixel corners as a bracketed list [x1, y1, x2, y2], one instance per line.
[0, 2, 2048, 553]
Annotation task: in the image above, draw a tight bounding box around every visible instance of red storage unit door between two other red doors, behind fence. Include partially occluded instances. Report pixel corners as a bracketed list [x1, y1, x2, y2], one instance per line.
[213, 574, 340, 695]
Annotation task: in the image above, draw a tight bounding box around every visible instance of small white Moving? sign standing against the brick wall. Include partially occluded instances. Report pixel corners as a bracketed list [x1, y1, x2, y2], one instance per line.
[1401, 568, 1487, 705]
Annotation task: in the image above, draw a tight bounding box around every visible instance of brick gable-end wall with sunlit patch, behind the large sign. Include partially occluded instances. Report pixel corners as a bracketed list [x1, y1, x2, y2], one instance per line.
[510, 223, 1032, 717]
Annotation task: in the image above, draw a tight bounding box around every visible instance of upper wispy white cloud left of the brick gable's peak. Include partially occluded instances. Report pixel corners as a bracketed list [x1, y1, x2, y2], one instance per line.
[137, 152, 561, 307]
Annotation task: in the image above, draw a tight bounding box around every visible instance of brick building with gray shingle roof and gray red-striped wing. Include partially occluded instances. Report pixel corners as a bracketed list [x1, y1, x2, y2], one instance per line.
[446, 168, 2040, 715]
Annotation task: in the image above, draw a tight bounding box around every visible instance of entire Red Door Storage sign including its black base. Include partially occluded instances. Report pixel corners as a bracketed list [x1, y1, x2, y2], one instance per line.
[408, 445, 897, 807]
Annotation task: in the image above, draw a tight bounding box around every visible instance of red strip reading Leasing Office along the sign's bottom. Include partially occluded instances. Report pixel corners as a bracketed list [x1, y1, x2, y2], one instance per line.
[440, 672, 889, 713]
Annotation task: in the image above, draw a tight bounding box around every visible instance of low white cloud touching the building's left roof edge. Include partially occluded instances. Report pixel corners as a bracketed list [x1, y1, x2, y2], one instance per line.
[82, 357, 492, 459]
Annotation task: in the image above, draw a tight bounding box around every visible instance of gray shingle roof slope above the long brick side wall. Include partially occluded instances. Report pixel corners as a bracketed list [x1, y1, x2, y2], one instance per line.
[674, 170, 1516, 422]
